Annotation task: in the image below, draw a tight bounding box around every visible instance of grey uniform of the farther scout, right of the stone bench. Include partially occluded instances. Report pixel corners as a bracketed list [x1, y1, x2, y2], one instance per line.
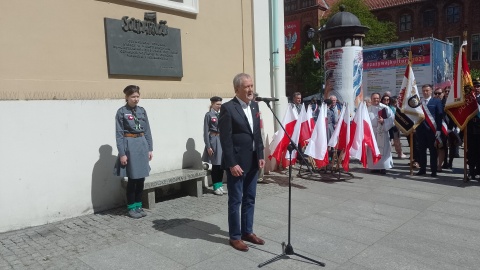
[202, 109, 222, 165]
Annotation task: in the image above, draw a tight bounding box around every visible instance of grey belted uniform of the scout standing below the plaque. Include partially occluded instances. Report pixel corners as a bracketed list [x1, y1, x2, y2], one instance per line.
[113, 105, 153, 179]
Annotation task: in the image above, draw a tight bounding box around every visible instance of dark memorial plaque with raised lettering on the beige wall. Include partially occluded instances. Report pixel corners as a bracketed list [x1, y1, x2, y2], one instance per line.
[105, 16, 183, 77]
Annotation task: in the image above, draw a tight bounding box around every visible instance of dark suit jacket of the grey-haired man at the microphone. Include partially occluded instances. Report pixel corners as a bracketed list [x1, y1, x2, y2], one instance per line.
[218, 97, 264, 173]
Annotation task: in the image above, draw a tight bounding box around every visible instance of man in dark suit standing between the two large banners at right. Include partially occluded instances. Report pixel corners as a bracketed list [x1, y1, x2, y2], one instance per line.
[415, 84, 443, 177]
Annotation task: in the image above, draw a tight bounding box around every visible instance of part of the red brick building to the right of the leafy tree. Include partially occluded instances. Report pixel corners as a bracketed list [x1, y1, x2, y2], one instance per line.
[364, 0, 480, 69]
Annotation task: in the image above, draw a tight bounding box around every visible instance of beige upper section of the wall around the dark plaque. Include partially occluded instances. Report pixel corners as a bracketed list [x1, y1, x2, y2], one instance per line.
[0, 0, 253, 100]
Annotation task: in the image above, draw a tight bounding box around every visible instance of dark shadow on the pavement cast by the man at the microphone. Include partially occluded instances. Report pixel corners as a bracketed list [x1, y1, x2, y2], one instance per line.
[152, 218, 229, 245]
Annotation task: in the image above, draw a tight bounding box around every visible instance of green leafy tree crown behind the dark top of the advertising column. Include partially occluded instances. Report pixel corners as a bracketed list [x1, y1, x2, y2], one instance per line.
[321, 0, 398, 45]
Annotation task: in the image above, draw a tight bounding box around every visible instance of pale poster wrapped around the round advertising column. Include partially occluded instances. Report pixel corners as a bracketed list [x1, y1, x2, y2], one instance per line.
[324, 46, 363, 116]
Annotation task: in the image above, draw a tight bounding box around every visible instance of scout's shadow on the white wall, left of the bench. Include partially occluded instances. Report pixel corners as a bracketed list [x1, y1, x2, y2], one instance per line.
[92, 144, 125, 212]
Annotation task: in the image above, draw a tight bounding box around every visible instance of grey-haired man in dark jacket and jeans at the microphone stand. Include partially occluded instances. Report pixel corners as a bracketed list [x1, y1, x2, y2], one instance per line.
[218, 73, 265, 251]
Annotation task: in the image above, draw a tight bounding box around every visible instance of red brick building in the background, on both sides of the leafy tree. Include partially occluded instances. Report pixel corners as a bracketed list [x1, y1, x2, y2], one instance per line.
[284, 0, 480, 74]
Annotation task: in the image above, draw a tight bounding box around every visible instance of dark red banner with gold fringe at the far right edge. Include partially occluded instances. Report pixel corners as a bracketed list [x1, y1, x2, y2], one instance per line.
[445, 41, 478, 130]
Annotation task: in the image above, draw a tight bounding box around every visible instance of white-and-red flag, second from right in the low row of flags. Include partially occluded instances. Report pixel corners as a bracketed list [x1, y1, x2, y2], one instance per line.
[328, 103, 351, 172]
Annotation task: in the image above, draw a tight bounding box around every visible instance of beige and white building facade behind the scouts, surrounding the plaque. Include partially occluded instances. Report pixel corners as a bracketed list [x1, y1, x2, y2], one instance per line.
[0, 0, 284, 232]
